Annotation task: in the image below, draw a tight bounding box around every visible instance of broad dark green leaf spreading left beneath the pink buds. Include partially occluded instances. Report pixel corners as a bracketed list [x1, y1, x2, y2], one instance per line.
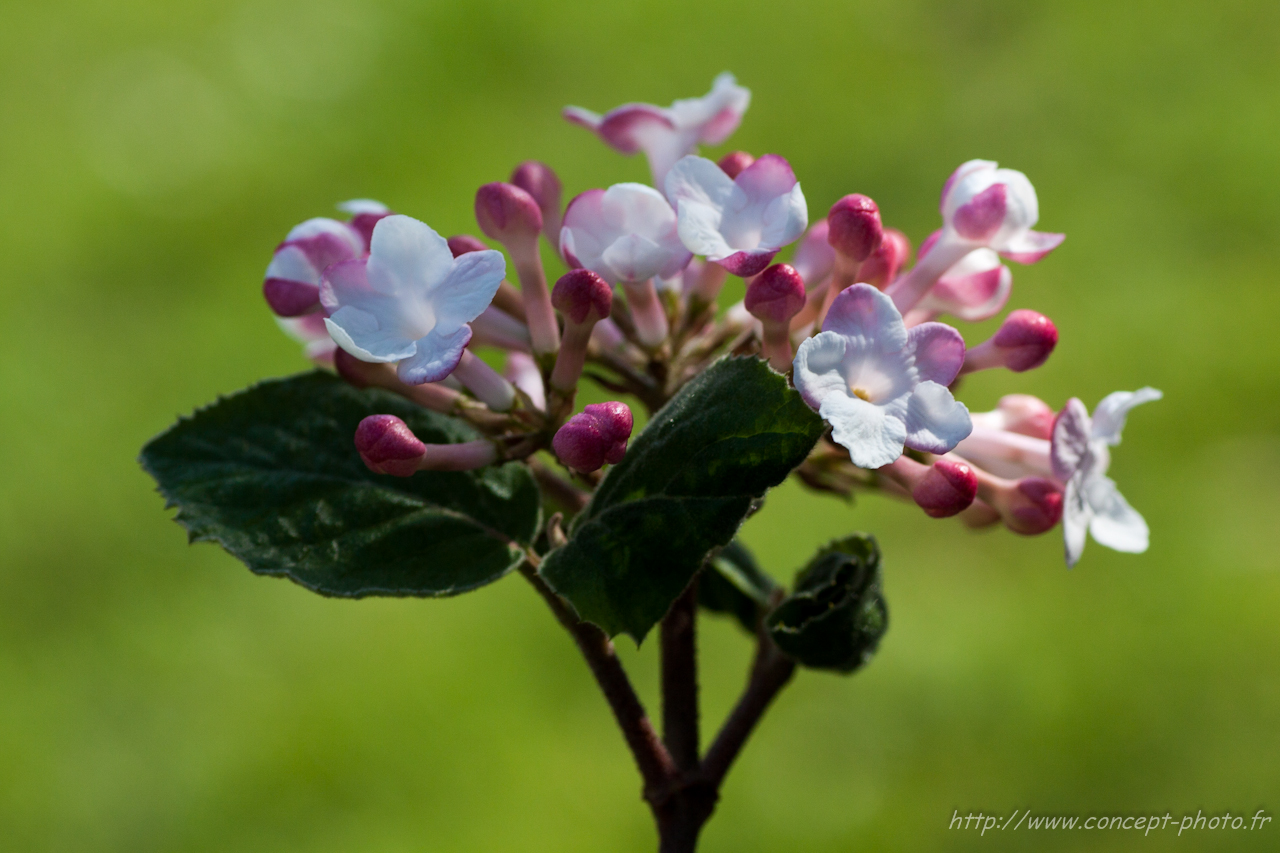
[141, 370, 540, 598]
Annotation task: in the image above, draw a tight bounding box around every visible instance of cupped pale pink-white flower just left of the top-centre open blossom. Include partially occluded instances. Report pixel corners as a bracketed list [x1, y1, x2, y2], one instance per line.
[561, 183, 692, 284]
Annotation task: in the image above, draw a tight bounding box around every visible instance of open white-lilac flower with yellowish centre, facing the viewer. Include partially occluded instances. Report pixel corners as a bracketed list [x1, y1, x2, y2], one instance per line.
[794, 284, 970, 467]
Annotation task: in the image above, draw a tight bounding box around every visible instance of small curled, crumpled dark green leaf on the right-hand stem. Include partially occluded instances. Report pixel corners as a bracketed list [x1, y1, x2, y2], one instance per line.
[765, 534, 888, 672]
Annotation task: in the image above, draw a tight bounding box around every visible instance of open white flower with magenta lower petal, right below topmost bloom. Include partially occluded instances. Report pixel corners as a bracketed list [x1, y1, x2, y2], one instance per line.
[666, 154, 809, 278]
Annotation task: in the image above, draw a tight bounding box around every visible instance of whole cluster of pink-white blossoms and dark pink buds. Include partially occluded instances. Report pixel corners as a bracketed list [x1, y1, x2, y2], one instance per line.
[264, 74, 1160, 565]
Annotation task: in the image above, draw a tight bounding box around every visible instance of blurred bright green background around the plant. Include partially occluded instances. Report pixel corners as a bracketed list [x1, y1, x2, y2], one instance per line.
[0, 0, 1280, 853]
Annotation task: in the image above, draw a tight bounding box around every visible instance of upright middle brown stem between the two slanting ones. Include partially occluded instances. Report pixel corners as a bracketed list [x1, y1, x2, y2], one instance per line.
[662, 576, 698, 771]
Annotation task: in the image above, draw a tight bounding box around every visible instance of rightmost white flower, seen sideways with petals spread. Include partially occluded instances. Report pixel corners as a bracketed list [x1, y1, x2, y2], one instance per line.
[1051, 388, 1162, 566]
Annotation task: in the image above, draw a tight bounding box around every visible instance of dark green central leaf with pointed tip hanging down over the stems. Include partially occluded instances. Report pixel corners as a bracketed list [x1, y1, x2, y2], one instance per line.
[541, 357, 823, 643]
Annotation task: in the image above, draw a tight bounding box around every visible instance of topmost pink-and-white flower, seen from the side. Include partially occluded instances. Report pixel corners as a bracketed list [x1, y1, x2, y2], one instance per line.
[563, 72, 751, 187]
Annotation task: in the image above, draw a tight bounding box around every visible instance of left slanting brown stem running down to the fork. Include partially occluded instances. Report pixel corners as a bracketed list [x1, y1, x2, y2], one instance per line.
[520, 562, 676, 797]
